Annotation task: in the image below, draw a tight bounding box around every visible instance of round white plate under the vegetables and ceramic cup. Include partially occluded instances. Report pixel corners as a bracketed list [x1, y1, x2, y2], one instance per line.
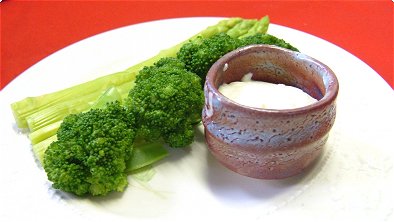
[0, 18, 394, 221]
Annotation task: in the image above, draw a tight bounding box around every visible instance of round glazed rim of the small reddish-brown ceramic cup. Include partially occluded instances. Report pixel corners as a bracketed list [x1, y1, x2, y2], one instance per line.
[204, 44, 339, 115]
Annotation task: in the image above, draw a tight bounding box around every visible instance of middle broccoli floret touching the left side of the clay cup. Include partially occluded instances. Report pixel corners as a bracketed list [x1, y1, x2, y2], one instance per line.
[126, 57, 204, 147]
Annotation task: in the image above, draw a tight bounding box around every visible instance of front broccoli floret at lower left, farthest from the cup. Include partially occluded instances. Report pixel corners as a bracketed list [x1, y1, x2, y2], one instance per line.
[43, 102, 135, 195]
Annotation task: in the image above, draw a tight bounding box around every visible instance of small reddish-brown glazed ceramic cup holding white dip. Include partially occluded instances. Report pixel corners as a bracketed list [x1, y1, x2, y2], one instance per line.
[203, 45, 339, 179]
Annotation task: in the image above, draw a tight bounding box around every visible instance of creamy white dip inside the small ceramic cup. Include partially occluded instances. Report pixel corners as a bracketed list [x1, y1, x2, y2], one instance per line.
[219, 73, 316, 109]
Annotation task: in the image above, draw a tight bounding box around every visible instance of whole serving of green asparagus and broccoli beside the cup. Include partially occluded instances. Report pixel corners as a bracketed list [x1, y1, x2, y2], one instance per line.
[11, 16, 297, 195]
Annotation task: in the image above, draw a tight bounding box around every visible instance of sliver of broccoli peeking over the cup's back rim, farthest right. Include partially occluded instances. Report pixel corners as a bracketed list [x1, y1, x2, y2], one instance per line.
[240, 34, 298, 52]
